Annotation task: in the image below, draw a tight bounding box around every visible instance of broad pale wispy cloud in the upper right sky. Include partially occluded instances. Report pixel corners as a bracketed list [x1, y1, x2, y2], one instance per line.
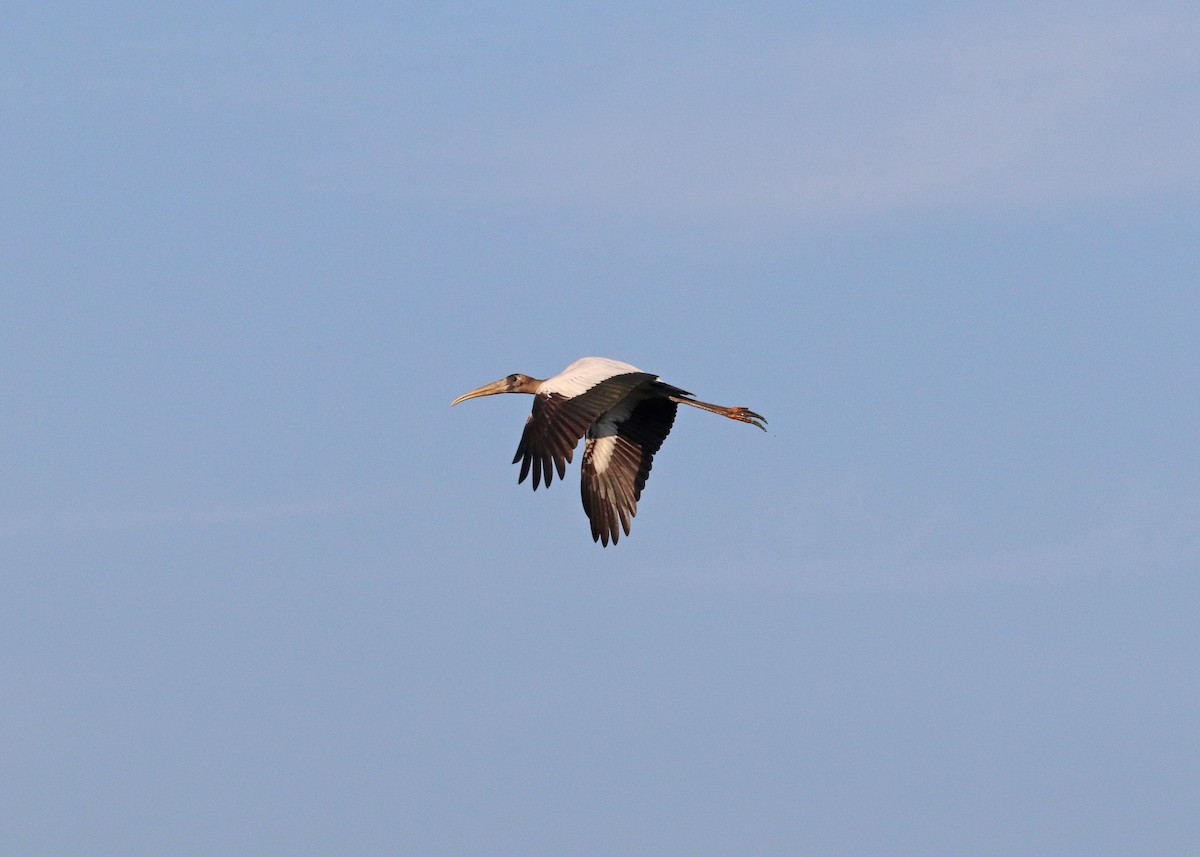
[420, 7, 1200, 220]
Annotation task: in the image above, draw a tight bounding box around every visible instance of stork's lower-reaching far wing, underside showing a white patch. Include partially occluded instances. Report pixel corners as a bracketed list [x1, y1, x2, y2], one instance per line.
[582, 398, 677, 547]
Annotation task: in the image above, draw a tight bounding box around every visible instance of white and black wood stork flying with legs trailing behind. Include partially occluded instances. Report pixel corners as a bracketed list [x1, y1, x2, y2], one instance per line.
[450, 356, 767, 547]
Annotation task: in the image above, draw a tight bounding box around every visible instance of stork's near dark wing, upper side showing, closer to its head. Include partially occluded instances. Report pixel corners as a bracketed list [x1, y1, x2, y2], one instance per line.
[512, 372, 654, 491]
